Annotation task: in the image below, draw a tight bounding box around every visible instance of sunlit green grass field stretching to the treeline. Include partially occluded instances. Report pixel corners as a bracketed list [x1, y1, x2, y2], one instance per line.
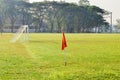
[0, 34, 120, 80]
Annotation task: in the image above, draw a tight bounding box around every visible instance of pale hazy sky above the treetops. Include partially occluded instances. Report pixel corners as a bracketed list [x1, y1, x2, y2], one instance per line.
[29, 0, 120, 24]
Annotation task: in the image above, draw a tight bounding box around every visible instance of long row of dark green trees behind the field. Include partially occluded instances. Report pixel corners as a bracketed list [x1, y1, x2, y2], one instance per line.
[0, 0, 110, 33]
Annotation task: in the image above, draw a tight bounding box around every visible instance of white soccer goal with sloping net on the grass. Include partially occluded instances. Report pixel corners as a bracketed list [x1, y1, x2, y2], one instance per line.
[10, 25, 29, 43]
